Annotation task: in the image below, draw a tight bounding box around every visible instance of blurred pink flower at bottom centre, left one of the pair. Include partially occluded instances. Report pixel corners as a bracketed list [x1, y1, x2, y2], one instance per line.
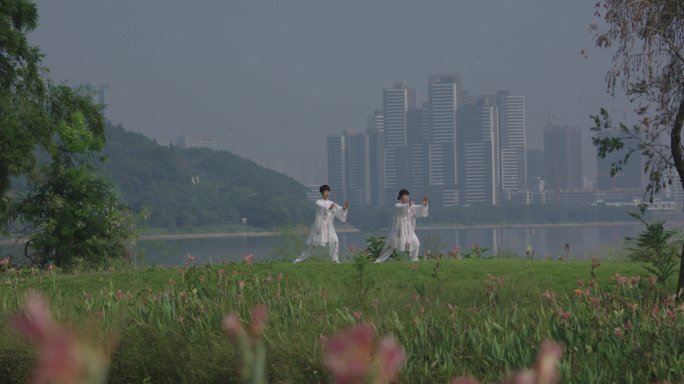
[324, 324, 373, 384]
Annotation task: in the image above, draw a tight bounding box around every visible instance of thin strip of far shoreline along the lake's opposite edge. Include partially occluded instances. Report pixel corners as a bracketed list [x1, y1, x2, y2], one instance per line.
[0, 221, 684, 245]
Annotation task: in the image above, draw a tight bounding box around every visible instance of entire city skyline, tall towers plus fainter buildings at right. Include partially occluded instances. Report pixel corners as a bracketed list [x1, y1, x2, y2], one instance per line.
[327, 74, 684, 206]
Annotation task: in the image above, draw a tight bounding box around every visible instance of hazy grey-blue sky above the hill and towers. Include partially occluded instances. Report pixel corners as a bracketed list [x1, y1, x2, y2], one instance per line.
[31, 0, 623, 181]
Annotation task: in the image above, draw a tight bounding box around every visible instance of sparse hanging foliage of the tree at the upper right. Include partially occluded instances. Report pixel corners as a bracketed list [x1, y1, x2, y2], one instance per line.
[592, 0, 684, 291]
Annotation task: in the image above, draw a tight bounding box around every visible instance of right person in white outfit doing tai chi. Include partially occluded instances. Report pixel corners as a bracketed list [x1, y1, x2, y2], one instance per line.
[375, 189, 428, 263]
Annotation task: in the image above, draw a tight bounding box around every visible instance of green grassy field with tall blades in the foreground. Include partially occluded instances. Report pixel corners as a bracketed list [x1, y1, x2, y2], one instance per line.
[0, 259, 684, 383]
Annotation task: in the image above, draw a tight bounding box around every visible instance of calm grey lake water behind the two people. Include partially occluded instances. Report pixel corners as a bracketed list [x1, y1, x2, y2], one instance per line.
[0, 223, 672, 265]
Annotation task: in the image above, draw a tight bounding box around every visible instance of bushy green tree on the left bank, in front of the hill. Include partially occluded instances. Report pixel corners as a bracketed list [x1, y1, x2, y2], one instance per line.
[15, 86, 134, 267]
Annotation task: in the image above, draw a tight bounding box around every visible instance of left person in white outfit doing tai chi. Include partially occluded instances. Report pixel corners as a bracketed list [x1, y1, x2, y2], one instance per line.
[294, 184, 349, 263]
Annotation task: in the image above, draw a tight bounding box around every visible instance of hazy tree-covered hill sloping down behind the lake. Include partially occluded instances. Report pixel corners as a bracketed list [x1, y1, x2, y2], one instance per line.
[104, 126, 313, 228]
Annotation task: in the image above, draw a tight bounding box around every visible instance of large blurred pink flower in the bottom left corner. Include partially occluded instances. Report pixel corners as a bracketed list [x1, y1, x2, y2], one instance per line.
[14, 292, 109, 384]
